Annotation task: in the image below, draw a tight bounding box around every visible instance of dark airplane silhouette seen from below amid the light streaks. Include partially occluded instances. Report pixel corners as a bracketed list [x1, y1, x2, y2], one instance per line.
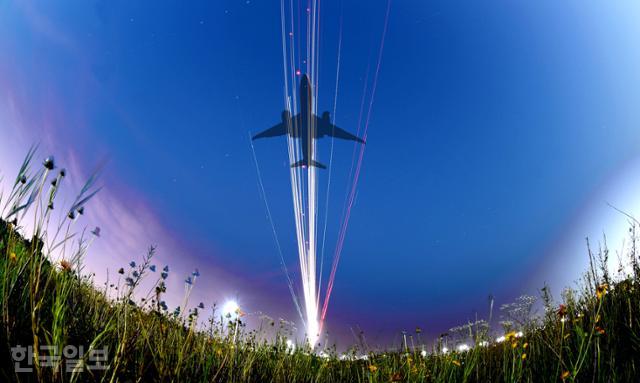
[252, 74, 365, 169]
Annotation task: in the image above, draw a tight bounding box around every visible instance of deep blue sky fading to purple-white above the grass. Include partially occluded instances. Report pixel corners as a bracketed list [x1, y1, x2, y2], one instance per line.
[0, 0, 640, 344]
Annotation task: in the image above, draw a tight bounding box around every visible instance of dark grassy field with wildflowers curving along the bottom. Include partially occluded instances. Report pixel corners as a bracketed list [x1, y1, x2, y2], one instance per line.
[0, 149, 640, 382]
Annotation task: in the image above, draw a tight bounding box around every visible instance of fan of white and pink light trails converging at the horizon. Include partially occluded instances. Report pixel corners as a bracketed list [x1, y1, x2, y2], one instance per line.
[272, 0, 391, 348]
